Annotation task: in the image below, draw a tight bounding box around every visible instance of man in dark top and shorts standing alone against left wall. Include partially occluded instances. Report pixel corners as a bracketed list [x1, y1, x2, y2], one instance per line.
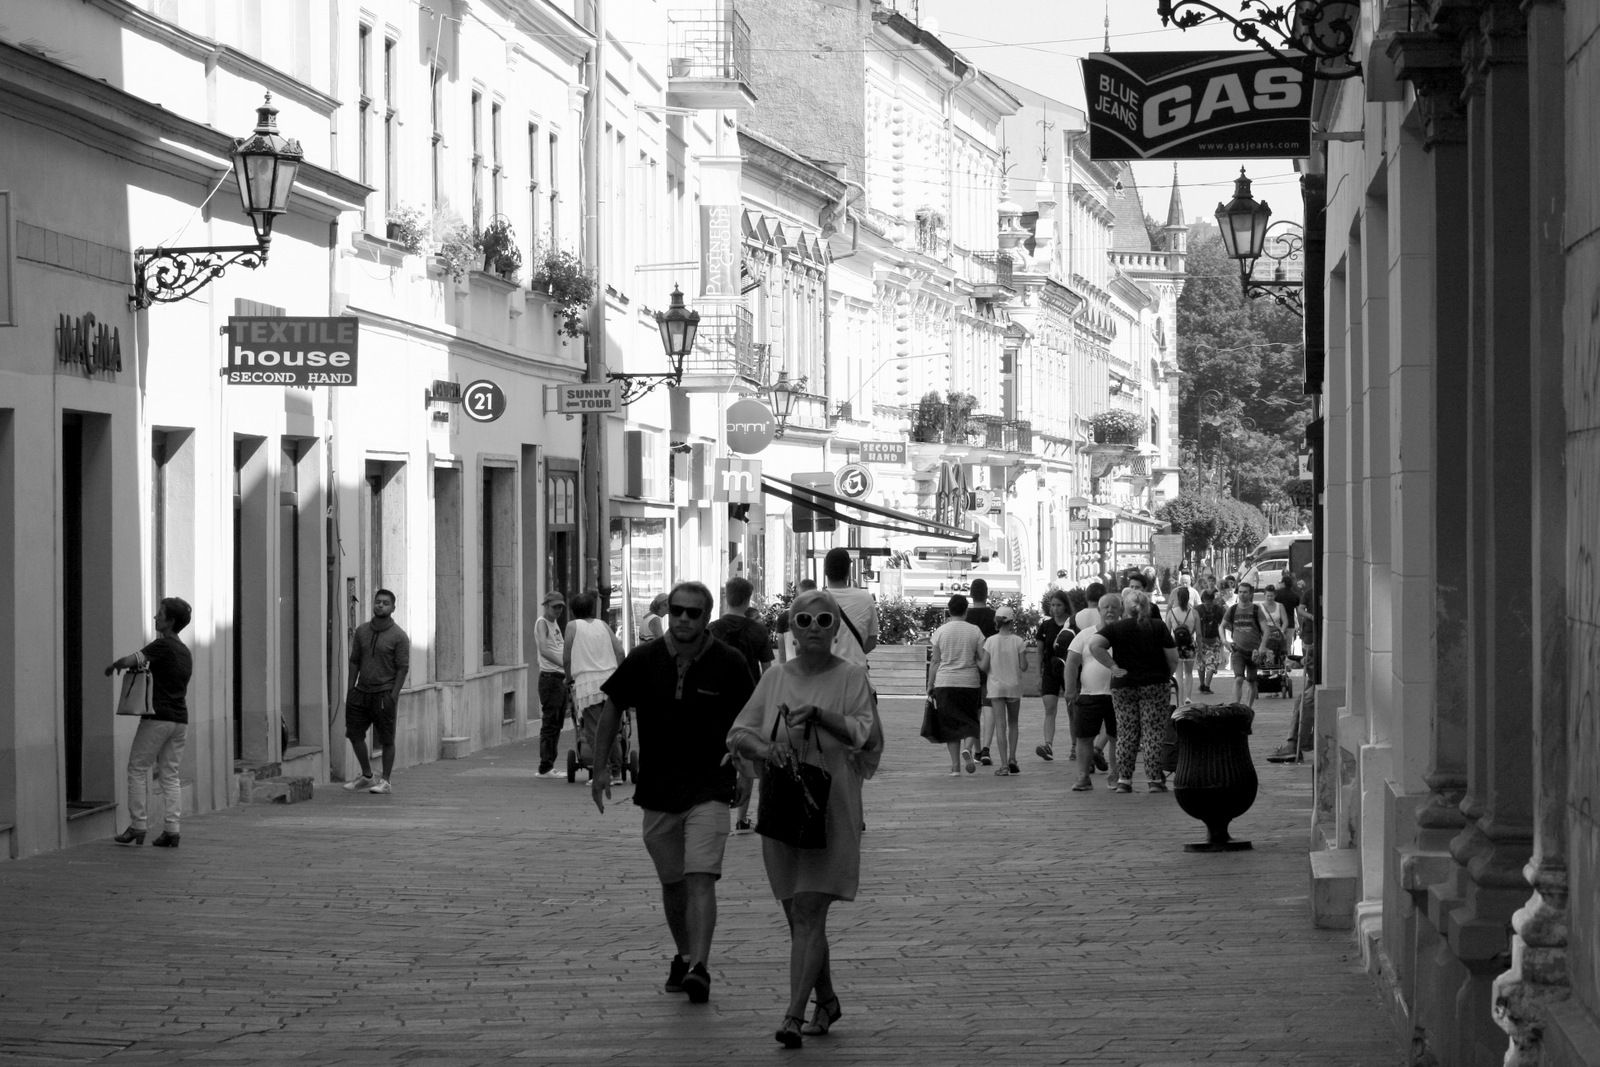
[344, 589, 411, 793]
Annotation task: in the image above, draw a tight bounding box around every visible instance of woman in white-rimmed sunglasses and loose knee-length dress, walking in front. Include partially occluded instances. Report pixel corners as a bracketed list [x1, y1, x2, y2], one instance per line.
[728, 589, 883, 1048]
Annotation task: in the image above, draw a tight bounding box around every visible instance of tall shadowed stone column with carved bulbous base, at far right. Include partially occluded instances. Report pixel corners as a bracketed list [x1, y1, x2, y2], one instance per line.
[1494, 0, 1574, 1067]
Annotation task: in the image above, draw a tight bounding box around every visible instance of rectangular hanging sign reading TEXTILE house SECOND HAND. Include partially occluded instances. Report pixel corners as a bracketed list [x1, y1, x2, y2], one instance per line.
[222, 315, 360, 386]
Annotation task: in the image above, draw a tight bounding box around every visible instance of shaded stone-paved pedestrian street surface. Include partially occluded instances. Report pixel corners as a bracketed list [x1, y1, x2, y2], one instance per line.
[0, 683, 1405, 1067]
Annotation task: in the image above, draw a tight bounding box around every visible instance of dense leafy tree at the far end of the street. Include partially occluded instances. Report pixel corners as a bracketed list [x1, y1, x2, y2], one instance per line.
[1178, 224, 1310, 504]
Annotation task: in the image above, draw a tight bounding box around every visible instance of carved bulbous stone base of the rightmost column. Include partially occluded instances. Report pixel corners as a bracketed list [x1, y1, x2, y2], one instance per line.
[1494, 862, 1573, 1067]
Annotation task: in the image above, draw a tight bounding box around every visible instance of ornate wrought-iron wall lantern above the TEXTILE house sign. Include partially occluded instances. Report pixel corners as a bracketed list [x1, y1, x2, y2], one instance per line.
[128, 93, 306, 310]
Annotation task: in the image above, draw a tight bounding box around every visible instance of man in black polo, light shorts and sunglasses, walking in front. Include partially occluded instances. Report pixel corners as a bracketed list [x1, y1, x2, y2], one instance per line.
[589, 582, 755, 1005]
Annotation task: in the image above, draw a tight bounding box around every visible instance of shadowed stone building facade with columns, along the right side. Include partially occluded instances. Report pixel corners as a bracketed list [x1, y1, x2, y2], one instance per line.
[1304, 2, 1600, 1065]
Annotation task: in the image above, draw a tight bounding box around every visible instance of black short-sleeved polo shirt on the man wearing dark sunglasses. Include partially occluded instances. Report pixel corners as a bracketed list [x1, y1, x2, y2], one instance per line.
[600, 637, 755, 813]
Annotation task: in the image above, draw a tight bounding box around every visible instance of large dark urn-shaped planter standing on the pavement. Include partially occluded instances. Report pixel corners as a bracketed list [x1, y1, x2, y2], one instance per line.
[1173, 704, 1258, 853]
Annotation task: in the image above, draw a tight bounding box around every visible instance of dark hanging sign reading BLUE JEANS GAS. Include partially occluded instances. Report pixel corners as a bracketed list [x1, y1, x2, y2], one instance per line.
[1083, 51, 1314, 160]
